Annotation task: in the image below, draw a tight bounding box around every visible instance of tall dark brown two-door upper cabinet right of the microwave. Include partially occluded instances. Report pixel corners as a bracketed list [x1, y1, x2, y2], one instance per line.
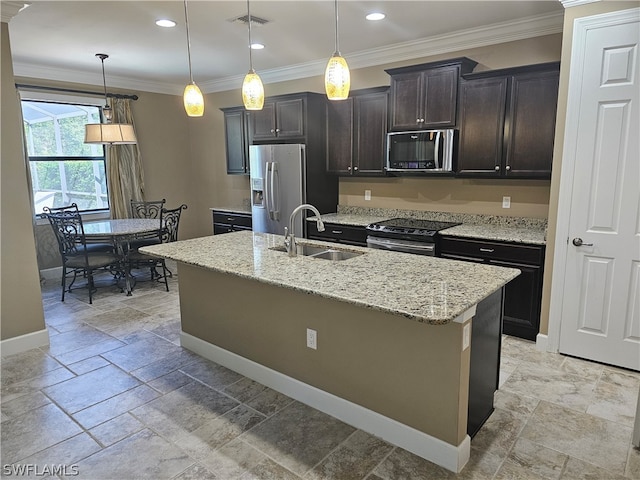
[457, 62, 560, 179]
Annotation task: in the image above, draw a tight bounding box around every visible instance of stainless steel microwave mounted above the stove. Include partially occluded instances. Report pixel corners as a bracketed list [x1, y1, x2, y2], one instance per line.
[387, 129, 456, 173]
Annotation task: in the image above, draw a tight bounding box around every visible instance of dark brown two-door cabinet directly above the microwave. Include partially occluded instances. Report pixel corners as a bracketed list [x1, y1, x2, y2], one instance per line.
[385, 57, 477, 131]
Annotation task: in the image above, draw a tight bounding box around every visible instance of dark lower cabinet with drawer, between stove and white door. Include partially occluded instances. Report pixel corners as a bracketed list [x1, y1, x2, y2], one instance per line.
[440, 237, 545, 340]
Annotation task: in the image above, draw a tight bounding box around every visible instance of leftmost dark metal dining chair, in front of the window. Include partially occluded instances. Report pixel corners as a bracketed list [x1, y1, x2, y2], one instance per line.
[44, 204, 122, 304]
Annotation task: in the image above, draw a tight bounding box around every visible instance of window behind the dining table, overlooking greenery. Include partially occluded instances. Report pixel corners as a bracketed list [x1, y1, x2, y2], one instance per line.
[22, 100, 109, 215]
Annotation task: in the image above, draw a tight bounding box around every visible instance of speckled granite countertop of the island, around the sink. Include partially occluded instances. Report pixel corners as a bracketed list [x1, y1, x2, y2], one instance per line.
[140, 231, 520, 325]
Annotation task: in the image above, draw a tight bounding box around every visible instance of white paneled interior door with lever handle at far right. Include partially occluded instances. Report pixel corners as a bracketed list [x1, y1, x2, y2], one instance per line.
[552, 9, 640, 370]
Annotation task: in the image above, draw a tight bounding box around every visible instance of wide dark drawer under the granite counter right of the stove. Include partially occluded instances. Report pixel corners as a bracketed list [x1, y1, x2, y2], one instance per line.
[440, 237, 544, 266]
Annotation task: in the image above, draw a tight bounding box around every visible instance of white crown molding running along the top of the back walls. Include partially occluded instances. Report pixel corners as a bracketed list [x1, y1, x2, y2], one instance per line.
[12, 11, 564, 95]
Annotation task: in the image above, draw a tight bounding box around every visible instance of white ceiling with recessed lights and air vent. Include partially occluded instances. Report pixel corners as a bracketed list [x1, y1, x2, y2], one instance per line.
[2, 0, 564, 95]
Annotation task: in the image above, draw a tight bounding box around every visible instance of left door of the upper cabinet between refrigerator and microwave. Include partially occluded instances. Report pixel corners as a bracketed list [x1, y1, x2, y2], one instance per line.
[326, 98, 356, 174]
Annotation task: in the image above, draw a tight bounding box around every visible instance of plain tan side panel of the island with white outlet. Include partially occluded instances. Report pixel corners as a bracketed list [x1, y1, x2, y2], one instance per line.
[179, 263, 470, 446]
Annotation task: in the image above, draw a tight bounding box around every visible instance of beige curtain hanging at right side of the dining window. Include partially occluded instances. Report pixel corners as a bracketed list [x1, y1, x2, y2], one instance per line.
[107, 98, 144, 219]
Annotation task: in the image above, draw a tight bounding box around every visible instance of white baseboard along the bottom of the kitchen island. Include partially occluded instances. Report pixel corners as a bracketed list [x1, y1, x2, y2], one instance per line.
[180, 332, 471, 473]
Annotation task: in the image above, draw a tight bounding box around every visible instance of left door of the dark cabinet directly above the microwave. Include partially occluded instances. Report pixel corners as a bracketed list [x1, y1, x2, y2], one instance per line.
[390, 72, 422, 131]
